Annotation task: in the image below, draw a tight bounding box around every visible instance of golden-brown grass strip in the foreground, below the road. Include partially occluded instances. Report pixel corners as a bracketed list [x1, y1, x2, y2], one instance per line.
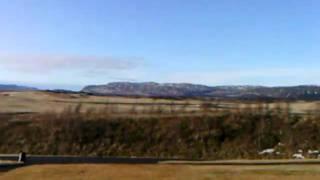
[0, 165, 320, 180]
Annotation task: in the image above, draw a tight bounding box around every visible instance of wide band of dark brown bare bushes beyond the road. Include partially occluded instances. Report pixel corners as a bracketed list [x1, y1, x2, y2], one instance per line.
[0, 105, 320, 159]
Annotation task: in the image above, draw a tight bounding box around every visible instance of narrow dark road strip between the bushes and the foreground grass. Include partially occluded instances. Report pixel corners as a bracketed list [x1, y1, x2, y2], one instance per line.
[0, 154, 320, 168]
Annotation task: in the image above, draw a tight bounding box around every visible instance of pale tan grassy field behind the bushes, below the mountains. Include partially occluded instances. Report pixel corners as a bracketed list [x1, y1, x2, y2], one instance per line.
[0, 92, 320, 114]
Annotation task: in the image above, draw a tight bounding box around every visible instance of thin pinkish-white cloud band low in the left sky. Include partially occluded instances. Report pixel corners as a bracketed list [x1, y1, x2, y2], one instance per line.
[0, 53, 141, 74]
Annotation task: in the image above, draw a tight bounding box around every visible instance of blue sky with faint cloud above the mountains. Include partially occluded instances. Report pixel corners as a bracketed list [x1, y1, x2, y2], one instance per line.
[0, 0, 320, 89]
